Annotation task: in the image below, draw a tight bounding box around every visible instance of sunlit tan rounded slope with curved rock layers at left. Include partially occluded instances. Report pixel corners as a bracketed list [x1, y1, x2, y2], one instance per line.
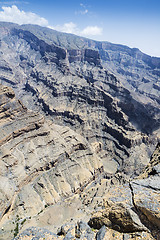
[0, 86, 102, 238]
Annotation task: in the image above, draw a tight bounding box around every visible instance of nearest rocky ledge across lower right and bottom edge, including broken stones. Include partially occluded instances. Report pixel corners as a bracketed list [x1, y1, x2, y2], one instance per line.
[12, 144, 160, 240]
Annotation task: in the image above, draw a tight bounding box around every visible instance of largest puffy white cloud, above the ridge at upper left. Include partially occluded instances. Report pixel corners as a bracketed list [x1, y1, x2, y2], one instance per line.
[0, 5, 48, 27]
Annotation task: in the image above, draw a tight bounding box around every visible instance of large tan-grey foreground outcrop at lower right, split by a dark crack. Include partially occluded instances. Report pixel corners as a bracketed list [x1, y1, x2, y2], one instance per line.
[89, 144, 160, 239]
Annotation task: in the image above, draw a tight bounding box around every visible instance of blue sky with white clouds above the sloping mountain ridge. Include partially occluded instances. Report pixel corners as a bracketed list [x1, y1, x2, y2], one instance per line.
[0, 0, 160, 57]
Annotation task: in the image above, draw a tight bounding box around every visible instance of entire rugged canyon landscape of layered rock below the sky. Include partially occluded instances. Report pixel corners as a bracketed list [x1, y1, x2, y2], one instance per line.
[0, 23, 160, 239]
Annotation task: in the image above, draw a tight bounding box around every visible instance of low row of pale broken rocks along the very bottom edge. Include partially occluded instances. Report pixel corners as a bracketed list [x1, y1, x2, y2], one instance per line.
[13, 223, 154, 240]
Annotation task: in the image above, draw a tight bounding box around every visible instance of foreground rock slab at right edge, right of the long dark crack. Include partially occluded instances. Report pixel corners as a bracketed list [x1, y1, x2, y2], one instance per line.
[131, 144, 160, 237]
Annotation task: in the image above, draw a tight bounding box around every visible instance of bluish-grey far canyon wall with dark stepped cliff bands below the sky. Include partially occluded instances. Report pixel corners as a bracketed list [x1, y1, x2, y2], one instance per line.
[0, 23, 160, 179]
